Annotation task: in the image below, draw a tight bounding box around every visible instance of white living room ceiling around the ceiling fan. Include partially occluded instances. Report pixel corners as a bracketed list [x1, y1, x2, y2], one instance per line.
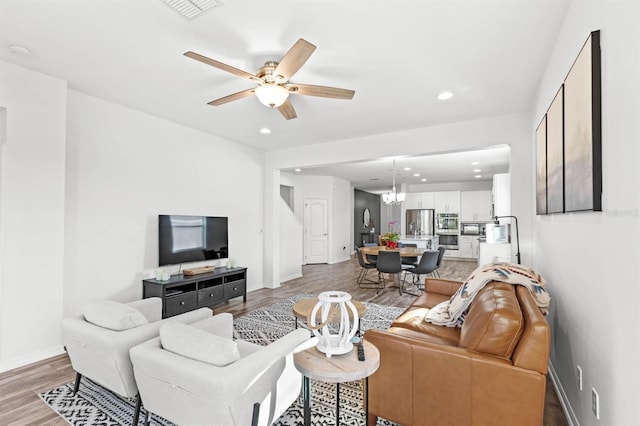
[0, 0, 569, 188]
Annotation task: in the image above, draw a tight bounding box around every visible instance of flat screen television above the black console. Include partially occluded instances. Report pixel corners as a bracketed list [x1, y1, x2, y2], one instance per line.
[158, 215, 229, 266]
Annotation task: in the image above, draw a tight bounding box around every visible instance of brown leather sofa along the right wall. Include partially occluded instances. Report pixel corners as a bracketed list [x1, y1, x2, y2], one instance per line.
[364, 279, 549, 426]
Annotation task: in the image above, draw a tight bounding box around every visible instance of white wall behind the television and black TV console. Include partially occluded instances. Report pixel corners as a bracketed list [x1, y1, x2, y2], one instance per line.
[64, 91, 264, 315]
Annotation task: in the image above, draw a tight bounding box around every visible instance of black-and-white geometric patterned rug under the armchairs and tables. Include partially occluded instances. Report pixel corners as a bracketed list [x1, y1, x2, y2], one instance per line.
[39, 294, 404, 426]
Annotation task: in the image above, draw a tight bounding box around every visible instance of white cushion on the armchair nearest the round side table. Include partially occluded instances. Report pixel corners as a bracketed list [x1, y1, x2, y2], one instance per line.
[160, 321, 240, 367]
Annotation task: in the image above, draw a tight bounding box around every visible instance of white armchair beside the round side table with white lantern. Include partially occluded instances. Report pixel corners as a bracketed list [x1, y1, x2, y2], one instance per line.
[130, 313, 309, 426]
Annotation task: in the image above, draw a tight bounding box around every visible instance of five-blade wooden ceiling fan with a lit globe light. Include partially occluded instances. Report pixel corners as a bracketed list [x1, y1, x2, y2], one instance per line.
[184, 38, 356, 120]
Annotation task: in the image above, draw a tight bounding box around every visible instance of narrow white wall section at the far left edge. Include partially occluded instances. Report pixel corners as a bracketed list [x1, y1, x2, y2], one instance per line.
[0, 61, 67, 371]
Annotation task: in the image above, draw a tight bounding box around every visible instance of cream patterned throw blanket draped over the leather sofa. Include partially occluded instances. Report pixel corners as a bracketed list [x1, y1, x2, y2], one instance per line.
[424, 263, 551, 327]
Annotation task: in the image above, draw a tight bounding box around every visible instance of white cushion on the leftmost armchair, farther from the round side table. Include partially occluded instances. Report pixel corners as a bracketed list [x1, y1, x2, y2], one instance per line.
[83, 300, 149, 331]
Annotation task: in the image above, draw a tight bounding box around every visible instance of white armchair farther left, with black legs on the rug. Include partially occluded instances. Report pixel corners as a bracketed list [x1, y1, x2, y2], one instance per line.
[62, 297, 213, 425]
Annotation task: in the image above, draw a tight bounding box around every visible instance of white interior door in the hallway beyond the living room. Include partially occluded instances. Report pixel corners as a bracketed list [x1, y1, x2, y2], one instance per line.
[304, 198, 329, 264]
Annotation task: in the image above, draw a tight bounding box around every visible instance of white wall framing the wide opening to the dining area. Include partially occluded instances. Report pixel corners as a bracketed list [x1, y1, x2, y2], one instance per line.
[265, 113, 533, 280]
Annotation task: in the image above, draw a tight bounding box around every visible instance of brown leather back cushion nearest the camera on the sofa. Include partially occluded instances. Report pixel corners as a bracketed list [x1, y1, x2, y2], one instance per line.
[460, 281, 525, 359]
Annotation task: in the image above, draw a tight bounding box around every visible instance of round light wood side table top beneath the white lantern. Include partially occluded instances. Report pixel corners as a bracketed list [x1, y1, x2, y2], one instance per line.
[293, 340, 380, 383]
